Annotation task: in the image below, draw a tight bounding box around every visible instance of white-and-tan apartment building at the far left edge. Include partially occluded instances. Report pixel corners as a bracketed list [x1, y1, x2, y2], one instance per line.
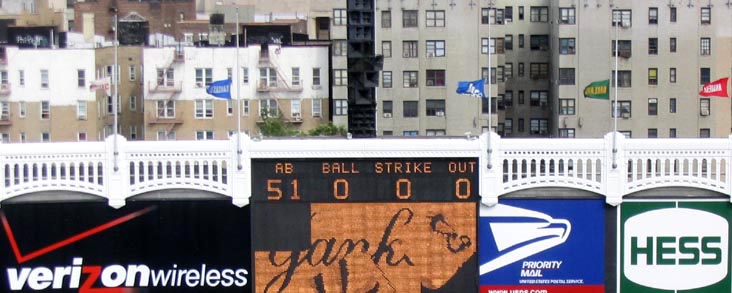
[0, 47, 104, 143]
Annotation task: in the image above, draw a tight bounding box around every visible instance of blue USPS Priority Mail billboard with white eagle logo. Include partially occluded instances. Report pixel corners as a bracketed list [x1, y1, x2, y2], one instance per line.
[478, 199, 605, 293]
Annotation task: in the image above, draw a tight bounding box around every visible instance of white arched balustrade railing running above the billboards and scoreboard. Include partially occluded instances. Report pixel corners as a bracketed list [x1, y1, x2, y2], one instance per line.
[0, 133, 732, 207]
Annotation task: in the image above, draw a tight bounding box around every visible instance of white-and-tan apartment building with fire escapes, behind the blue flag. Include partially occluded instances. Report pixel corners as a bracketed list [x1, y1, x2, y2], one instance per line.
[143, 44, 330, 140]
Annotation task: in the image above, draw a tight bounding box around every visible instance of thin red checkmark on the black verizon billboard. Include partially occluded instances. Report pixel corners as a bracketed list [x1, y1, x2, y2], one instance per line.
[0, 206, 155, 264]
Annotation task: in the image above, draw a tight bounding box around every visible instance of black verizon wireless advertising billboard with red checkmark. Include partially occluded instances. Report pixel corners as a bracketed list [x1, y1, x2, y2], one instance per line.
[0, 200, 252, 293]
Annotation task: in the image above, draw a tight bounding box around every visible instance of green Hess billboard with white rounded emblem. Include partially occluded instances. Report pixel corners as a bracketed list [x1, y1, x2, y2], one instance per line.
[618, 201, 732, 293]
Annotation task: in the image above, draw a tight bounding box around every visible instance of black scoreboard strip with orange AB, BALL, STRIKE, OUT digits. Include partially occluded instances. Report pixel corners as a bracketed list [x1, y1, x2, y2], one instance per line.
[252, 158, 479, 202]
